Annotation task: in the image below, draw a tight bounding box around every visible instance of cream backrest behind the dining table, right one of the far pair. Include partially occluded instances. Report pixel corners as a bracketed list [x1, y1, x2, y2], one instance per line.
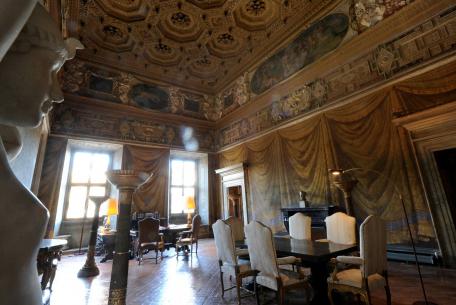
[325, 212, 356, 244]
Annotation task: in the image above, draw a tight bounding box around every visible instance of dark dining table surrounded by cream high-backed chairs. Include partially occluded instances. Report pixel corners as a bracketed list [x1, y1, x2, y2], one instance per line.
[236, 236, 358, 305]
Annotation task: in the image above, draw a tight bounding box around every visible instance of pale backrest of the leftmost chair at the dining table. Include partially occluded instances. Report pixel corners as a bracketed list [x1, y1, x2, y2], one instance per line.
[212, 219, 237, 265]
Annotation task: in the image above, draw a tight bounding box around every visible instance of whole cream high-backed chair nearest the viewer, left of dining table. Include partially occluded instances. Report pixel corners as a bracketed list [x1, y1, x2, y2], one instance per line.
[245, 221, 309, 305]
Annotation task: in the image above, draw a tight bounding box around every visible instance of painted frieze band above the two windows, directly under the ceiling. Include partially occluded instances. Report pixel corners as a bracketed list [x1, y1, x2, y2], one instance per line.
[61, 60, 222, 120]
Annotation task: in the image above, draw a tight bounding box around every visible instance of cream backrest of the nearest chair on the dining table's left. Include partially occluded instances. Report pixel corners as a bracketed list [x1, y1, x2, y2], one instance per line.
[245, 221, 279, 278]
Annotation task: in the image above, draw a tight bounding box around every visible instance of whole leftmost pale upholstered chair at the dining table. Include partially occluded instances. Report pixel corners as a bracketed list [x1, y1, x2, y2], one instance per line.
[212, 219, 255, 304]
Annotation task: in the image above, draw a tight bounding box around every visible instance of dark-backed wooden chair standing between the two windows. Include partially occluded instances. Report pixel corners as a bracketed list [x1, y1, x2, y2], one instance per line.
[138, 218, 165, 265]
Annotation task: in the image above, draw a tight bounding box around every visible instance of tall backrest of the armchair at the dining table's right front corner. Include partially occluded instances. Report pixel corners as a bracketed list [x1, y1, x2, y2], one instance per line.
[359, 215, 387, 278]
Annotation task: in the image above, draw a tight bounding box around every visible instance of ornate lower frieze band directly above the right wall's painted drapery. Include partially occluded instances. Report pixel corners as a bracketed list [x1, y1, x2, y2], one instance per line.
[219, 6, 456, 147]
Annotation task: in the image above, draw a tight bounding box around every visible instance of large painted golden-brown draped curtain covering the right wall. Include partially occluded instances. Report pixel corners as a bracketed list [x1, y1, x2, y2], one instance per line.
[220, 91, 434, 242]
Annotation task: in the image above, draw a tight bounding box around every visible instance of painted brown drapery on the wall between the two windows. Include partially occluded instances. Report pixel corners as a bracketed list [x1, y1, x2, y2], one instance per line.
[122, 145, 170, 217]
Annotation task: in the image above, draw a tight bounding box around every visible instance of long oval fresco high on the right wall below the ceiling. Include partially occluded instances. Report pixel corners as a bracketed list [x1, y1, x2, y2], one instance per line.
[250, 13, 349, 94]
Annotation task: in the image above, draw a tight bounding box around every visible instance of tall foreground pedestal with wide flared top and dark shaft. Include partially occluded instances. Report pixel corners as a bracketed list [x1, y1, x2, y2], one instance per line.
[107, 170, 149, 305]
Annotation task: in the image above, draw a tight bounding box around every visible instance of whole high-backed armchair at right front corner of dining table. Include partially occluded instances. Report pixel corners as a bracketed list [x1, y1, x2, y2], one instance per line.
[328, 215, 391, 305]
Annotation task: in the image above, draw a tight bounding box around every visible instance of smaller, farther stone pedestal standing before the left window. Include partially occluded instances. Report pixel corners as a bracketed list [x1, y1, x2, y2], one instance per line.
[78, 196, 109, 277]
